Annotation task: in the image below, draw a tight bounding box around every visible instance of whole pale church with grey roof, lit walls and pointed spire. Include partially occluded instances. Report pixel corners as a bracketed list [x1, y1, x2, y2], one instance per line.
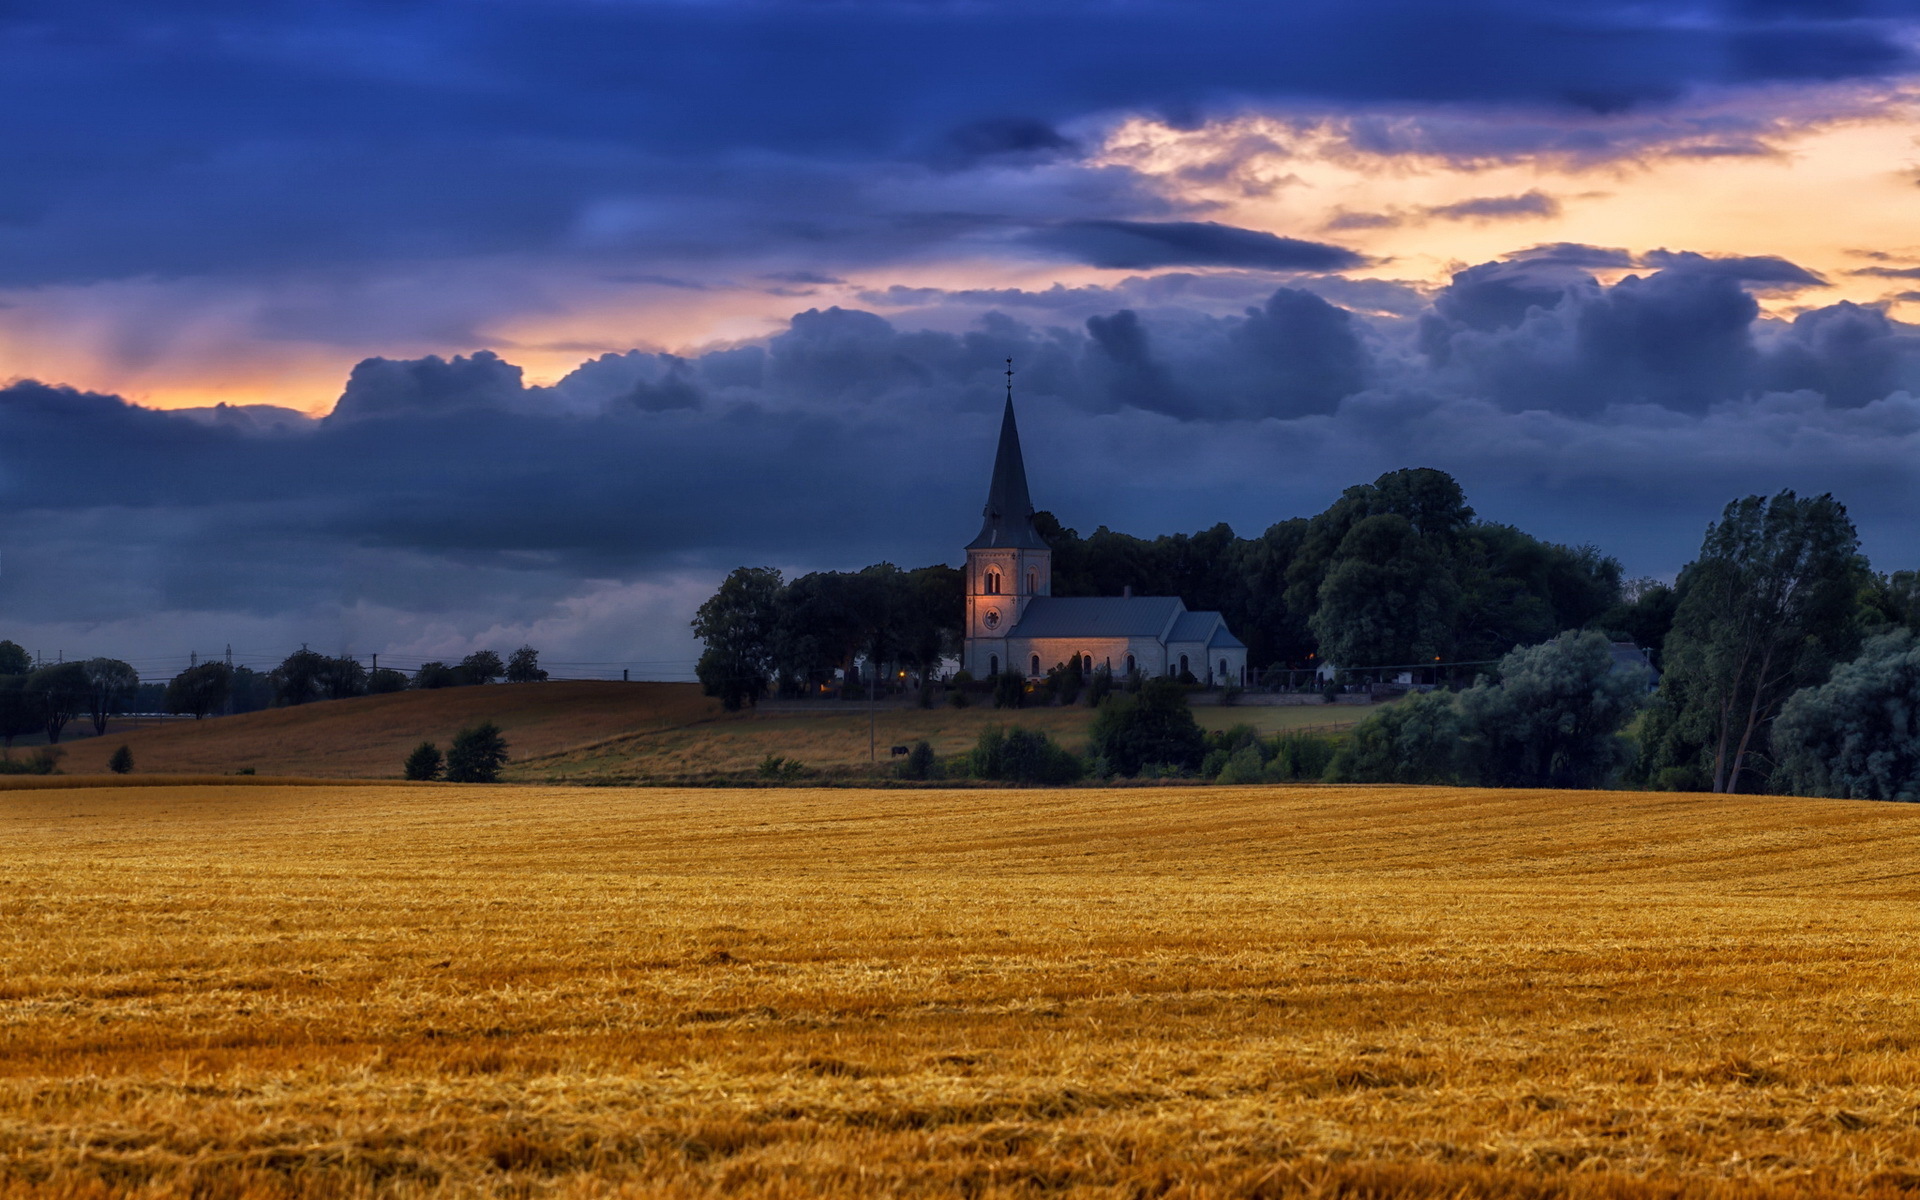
[960, 380, 1246, 687]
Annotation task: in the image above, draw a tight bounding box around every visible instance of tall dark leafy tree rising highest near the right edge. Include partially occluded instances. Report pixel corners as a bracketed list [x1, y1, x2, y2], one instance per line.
[1642, 492, 1868, 791]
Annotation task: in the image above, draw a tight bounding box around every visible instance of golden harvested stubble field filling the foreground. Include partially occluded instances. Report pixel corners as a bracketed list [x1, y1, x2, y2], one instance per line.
[0, 785, 1920, 1198]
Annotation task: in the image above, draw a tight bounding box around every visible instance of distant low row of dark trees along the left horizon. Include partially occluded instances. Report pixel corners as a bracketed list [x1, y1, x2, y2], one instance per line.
[0, 641, 547, 749]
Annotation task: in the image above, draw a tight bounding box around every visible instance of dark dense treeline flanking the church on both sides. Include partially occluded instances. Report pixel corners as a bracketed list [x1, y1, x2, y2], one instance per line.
[693, 468, 1674, 708]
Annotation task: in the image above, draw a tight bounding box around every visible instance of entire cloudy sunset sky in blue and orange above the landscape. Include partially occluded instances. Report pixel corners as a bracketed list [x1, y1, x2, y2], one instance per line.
[0, 0, 1920, 678]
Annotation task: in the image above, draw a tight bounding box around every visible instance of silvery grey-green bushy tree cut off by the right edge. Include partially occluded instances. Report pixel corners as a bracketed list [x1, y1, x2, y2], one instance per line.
[1772, 628, 1920, 801]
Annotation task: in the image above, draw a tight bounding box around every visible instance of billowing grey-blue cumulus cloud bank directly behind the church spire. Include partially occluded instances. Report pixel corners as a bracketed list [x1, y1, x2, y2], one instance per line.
[0, 248, 1920, 664]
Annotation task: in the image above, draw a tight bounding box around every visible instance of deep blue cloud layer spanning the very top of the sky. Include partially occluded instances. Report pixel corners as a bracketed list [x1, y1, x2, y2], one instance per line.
[0, 0, 1920, 286]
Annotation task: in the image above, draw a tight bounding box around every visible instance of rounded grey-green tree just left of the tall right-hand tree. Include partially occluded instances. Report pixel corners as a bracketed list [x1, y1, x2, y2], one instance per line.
[1457, 632, 1649, 787]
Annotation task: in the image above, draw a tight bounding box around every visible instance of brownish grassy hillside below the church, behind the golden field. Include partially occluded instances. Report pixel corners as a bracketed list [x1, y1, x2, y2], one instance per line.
[45, 682, 1365, 783]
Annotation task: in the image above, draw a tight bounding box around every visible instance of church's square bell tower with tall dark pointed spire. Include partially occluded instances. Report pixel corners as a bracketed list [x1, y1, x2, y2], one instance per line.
[962, 359, 1054, 678]
